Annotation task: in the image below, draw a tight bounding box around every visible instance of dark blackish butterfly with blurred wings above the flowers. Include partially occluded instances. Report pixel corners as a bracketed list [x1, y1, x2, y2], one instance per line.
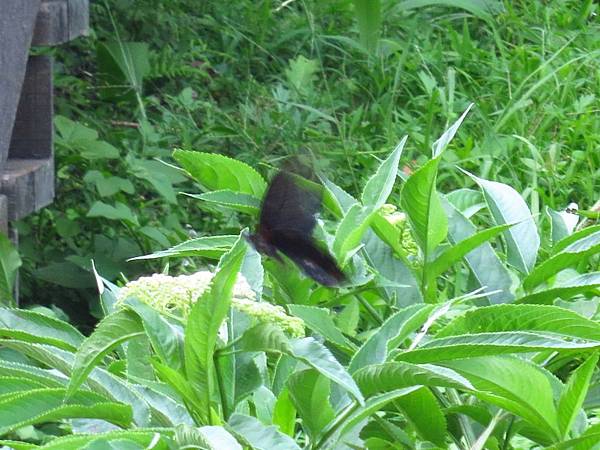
[249, 171, 346, 286]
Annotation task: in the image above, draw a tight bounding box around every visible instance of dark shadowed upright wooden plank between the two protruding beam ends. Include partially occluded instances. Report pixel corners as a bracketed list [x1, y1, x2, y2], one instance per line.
[8, 56, 53, 159]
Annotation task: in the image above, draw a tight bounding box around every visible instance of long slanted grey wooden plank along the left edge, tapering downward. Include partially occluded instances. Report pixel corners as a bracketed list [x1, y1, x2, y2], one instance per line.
[0, 0, 40, 167]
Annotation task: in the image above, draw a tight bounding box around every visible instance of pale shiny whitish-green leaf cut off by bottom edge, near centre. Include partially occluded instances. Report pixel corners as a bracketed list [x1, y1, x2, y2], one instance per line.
[229, 413, 300, 450]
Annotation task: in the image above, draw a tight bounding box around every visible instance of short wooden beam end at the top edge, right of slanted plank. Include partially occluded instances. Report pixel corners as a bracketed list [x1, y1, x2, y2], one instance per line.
[31, 0, 89, 45]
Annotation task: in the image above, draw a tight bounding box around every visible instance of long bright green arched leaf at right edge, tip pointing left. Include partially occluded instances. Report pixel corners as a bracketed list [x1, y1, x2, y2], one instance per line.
[436, 305, 600, 341]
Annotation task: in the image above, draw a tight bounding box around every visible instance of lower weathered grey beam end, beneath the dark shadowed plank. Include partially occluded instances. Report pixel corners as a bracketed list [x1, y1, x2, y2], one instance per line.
[0, 158, 54, 221]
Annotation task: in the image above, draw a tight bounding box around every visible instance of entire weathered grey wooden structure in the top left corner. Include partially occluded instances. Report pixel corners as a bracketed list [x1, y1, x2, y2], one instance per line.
[0, 0, 89, 232]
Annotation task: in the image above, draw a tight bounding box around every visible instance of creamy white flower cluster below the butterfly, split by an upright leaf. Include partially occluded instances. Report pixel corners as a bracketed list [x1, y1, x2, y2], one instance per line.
[118, 271, 304, 337]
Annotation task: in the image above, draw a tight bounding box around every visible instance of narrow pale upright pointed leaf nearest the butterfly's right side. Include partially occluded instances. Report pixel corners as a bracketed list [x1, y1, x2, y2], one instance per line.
[361, 136, 408, 209]
